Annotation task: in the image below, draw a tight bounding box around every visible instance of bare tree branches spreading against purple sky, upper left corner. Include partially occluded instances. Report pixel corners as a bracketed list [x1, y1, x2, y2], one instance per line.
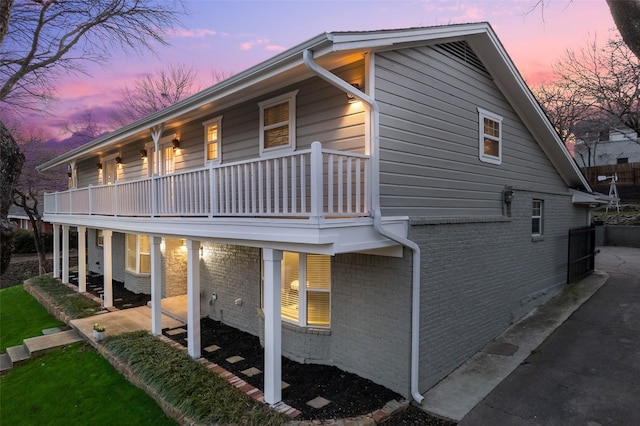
[0, 0, 184, 108]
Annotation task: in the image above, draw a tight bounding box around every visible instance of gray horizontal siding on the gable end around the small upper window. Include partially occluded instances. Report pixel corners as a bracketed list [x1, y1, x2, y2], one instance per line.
[375, 47, 566, 216]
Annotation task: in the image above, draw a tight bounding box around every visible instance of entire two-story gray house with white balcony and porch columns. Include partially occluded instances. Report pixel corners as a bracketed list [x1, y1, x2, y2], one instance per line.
[40, 23, 598, 403]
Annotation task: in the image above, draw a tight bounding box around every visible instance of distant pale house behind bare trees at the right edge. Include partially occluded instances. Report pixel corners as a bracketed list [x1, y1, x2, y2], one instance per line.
[574, 122, 640, 167]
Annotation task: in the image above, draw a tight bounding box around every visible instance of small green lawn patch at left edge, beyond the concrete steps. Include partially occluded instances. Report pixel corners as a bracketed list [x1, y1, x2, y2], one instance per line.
[0, 285, 64, 352]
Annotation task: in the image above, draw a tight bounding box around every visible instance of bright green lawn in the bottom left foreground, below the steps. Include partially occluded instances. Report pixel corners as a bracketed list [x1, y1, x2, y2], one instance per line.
[0, 343, 175, 426]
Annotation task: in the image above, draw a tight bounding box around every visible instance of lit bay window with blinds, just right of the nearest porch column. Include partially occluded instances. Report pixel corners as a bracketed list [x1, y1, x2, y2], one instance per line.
[268, 252, 331, 327]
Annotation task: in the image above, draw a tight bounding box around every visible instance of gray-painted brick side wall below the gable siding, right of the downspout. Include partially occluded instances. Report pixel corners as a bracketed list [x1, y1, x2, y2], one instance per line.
[409, 191, 587, 391]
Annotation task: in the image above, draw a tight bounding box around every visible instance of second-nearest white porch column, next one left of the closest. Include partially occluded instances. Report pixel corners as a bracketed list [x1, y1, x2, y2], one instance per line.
[187, 240, 202, 359]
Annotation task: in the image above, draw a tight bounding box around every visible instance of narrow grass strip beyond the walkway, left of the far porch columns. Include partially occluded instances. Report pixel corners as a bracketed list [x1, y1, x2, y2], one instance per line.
[30, 274, 102, 319]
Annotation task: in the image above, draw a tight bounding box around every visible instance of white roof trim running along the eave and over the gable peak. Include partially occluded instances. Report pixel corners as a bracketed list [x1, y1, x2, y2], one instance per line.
[38, 22, 591, 192]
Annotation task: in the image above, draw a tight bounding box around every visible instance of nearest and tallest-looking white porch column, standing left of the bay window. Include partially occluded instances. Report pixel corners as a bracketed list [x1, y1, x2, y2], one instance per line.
[262, 249, 282, 404]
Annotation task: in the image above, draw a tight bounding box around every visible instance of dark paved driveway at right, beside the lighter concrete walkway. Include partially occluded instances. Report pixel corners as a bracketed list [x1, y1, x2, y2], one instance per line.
[459, 247, 640, 426]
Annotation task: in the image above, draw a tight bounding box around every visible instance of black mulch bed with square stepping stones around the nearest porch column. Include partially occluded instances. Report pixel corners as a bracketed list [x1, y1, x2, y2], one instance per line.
[164, 318, 454, 426]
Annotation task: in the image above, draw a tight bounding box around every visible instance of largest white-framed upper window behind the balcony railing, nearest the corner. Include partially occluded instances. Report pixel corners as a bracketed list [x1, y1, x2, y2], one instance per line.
[258, 90, 298, 155]
